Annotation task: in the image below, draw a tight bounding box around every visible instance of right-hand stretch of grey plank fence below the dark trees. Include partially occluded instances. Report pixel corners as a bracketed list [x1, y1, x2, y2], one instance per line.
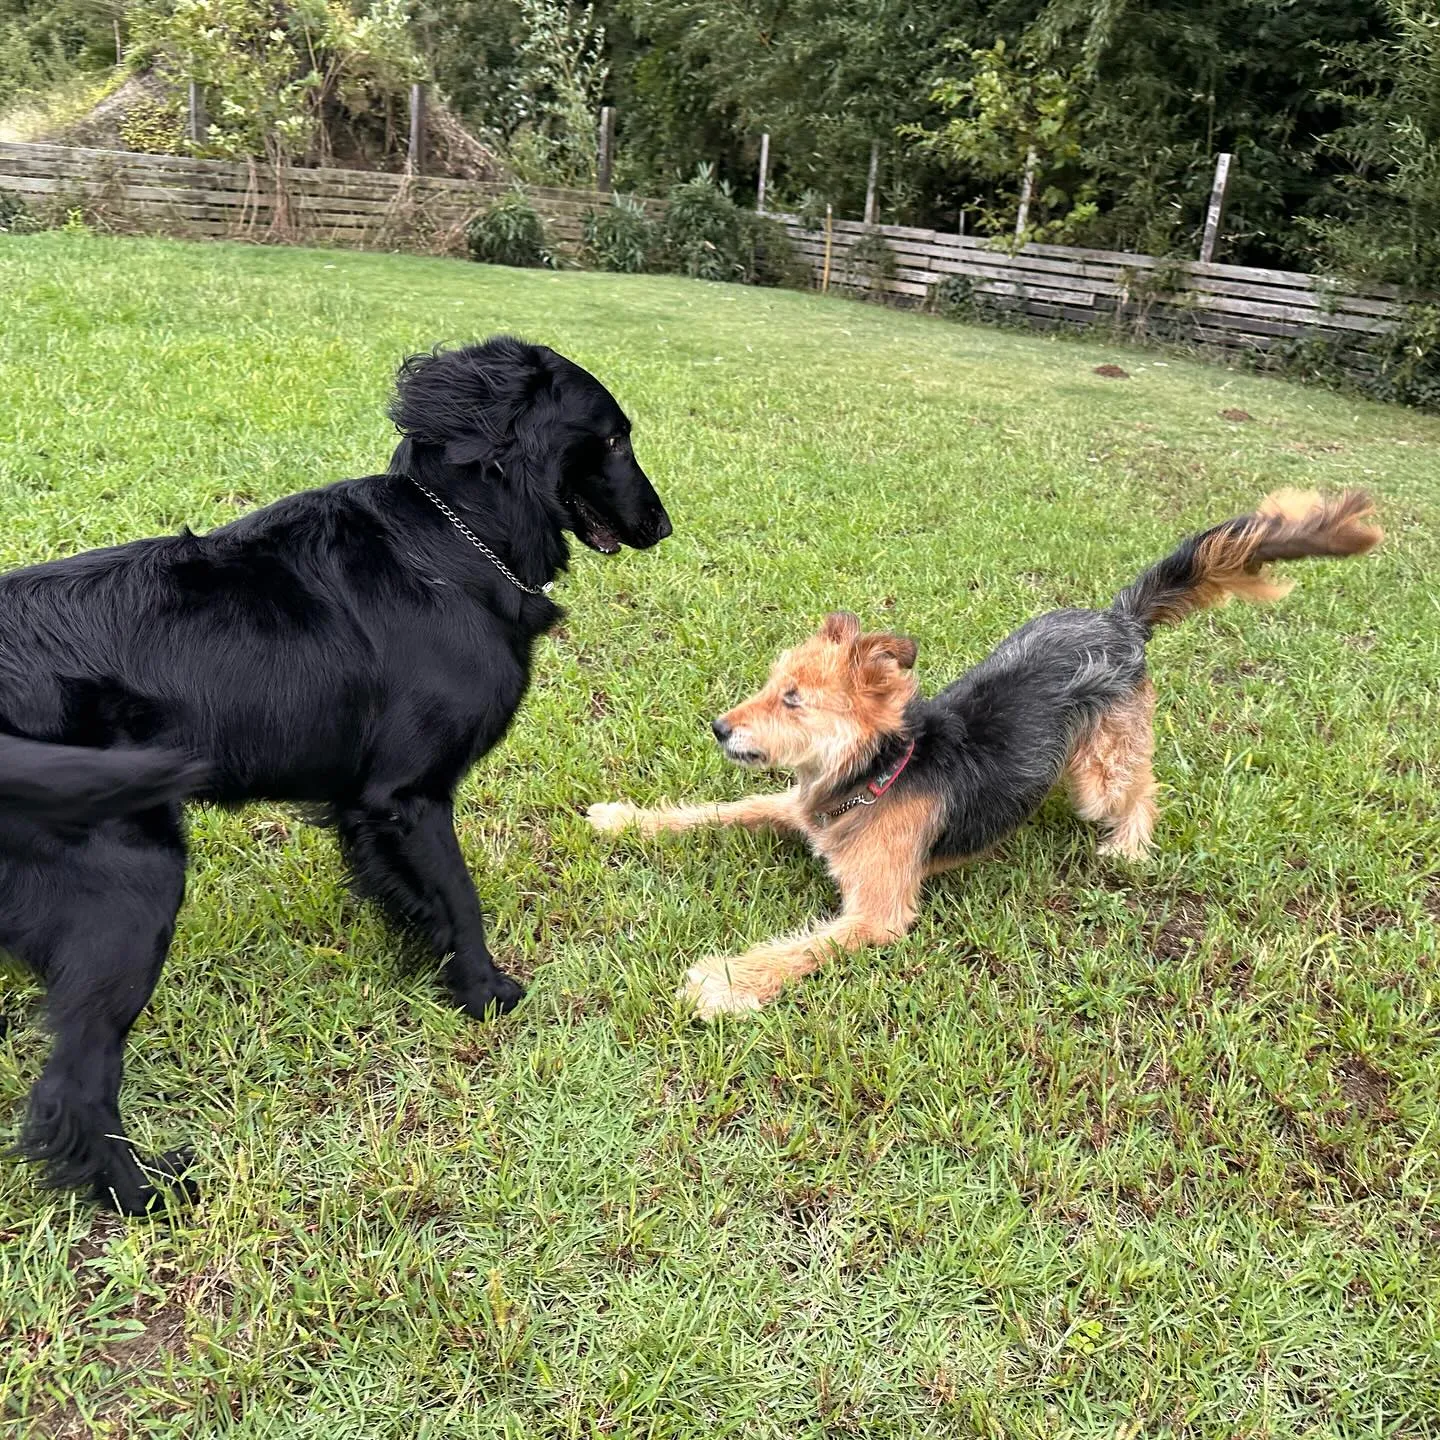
[776, 216, 1405, 364]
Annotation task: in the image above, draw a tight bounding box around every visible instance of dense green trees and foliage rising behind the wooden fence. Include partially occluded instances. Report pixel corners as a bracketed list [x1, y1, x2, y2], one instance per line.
[8, 0, 1440, 287]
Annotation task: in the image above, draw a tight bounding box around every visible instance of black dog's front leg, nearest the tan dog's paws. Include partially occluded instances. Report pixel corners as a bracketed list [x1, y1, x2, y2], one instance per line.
[338, 795, 524, 1018]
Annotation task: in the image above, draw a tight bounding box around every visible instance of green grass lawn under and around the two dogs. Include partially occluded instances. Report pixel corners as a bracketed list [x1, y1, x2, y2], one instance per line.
[0, 235, 1440, 1440]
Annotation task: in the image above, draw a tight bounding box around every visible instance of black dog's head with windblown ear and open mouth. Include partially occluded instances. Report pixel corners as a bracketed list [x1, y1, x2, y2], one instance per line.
[390, 336, 671, 554]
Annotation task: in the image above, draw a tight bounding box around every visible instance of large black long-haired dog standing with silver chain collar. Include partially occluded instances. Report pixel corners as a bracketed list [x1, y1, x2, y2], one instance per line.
[0, 337, 670, 1212]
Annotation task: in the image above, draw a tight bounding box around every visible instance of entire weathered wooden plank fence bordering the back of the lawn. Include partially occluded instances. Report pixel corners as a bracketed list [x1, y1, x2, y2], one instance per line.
[0, 143, 1405, 369]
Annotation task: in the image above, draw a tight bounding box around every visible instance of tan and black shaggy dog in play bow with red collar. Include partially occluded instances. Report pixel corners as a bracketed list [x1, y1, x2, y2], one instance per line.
[589, 491, 1382, 1017]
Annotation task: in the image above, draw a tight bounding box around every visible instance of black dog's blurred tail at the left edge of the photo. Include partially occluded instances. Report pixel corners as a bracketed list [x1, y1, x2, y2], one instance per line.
[0, 734, 207, 825]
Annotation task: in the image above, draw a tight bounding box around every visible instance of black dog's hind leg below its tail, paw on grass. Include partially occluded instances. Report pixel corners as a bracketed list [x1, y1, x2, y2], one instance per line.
[20, 837, 194, 1215]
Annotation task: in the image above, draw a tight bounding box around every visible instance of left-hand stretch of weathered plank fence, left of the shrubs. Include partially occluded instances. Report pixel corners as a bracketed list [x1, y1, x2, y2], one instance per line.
[0, 143, 603, 252]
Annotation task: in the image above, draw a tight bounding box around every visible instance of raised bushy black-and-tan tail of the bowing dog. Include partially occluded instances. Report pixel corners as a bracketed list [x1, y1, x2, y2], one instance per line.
[1115, 490, 1385, 628]
